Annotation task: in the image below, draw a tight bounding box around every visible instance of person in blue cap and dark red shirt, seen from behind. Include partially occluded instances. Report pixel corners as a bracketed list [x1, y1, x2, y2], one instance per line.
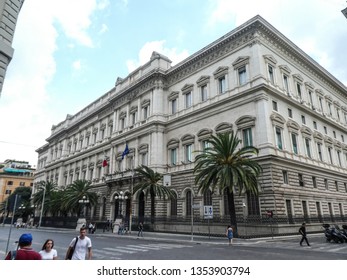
[5, 233, 41, 260]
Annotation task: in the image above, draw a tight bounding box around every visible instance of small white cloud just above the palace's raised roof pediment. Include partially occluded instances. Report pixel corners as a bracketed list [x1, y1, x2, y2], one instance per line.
[126, 40, 189, 72]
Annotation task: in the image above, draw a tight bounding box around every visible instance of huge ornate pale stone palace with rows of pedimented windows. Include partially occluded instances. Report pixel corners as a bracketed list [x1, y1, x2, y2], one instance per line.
[35, 16, 347, 235]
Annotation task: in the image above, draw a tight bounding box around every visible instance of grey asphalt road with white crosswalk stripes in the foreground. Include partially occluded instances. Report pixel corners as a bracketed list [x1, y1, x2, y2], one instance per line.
[0, 226, 347, 260]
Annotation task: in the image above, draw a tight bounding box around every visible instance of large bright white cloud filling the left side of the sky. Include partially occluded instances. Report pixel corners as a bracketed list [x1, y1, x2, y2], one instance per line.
[0, 0, 108, 165]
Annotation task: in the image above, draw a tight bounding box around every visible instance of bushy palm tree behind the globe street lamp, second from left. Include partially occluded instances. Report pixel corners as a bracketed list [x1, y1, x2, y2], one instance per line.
[62, 180, 98, 215]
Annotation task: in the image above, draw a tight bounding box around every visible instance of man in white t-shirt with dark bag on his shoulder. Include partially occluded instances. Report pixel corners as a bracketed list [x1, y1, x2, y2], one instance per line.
[65, 227, 92, 260]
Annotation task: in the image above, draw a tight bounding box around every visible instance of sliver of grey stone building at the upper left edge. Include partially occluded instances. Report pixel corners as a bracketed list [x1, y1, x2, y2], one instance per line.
[0, 0, 24, 96]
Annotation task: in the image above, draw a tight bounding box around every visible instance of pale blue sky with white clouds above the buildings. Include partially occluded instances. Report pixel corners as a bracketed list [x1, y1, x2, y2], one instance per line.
[0, 0, 347, 166]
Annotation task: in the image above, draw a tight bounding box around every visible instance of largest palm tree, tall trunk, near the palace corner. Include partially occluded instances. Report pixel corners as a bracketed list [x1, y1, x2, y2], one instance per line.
[194, 131, 262, 235]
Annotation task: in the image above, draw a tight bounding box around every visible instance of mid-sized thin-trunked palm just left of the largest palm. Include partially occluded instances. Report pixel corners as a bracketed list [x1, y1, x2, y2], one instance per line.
[133, 165, 174, 224]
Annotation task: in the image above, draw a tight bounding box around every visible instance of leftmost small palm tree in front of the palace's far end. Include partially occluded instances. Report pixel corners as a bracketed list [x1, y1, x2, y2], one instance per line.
[32, 181, 58, 215]
